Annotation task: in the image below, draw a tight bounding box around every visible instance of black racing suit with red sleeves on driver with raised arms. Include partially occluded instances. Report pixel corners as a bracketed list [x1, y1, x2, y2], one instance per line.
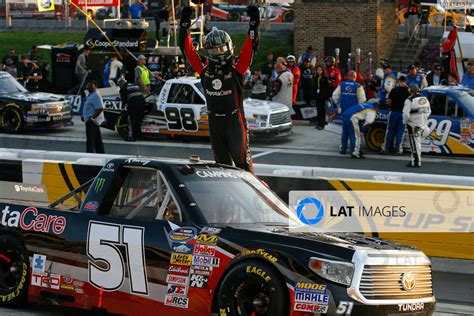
[179, 19, 259, 172]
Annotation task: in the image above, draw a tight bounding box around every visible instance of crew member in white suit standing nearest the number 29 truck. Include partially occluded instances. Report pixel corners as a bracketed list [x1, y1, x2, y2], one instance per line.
[403, 84, 431, 168]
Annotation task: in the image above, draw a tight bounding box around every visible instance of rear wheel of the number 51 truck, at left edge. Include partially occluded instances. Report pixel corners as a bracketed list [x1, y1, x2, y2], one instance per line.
[0, 234, 29, 306]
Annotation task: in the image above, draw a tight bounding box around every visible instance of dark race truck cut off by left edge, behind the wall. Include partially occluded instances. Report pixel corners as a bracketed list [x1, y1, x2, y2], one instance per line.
[0, 71, 72, 133]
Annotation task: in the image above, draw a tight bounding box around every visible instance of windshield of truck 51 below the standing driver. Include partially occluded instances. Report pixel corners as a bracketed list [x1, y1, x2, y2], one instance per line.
[175, 166, 291, 225]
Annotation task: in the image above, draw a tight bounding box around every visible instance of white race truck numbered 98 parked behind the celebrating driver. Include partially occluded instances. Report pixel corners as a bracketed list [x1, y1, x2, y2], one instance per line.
[100, 77, 292, 139]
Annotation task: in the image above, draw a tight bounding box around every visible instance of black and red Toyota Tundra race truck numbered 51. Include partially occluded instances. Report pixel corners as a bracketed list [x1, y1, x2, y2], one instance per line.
[0, 156, 435, 316]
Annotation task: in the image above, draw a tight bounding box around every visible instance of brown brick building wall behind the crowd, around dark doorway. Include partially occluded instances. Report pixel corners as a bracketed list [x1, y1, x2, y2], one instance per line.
[294, 0, 397, 72]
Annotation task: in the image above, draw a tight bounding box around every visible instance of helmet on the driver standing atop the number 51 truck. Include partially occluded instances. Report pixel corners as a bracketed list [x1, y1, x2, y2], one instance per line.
[204, 27, 234, 65]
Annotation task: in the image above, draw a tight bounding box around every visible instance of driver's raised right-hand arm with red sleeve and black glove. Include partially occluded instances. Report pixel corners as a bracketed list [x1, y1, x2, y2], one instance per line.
[235, 5, 260, 75]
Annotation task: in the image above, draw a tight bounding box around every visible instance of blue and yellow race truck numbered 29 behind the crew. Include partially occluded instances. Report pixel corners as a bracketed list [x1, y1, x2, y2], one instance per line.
[365, 86, 474, 155]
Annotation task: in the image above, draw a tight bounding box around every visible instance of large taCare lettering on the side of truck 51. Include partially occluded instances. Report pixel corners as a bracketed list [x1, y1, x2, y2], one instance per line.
[0, 205, 66, 235]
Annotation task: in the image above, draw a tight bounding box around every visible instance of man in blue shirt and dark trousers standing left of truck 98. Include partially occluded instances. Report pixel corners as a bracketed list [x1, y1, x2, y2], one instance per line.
[82, 81, 105, 154]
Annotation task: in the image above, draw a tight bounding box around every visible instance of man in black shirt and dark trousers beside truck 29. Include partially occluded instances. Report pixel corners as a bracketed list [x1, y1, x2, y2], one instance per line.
[381, 76, 410, 155]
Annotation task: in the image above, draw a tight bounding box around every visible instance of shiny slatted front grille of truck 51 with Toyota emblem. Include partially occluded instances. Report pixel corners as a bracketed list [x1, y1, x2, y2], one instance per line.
[359, 265, 433, 300]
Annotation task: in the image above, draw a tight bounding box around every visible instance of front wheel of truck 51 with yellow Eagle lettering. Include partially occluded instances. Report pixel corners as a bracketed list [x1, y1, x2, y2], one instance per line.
[217, 260, 290, 315]
